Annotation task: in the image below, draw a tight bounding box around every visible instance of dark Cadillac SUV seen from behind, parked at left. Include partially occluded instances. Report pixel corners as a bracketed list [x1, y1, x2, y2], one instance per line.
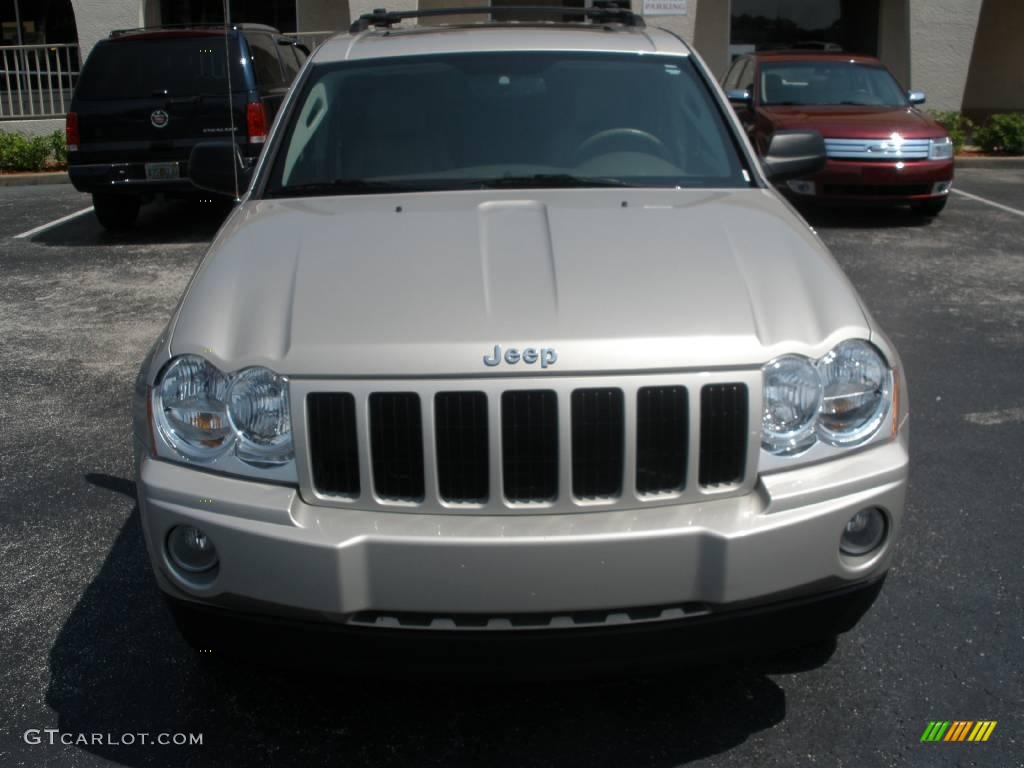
[68, 25, 308, 229]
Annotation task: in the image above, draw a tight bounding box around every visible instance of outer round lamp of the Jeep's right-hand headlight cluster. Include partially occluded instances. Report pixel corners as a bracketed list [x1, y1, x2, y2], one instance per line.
[817, 340, 893, 446]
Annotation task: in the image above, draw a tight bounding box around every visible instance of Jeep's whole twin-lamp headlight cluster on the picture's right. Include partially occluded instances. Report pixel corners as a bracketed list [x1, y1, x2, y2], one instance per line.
[761, 339, 894, 456]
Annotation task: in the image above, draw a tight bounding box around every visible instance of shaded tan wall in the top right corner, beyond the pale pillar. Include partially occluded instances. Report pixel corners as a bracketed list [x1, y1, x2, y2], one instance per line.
[964, 0, 1024, 116]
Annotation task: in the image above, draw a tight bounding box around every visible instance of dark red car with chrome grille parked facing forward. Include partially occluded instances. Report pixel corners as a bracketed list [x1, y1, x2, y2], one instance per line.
[722, 50, 953, 216]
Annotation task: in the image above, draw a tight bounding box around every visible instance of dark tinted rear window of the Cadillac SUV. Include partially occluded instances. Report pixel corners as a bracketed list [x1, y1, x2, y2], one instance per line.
[75, 35, 245, 100]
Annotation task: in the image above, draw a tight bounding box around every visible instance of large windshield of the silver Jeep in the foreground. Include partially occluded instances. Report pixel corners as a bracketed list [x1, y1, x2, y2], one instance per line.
[260, 52, 750, 197]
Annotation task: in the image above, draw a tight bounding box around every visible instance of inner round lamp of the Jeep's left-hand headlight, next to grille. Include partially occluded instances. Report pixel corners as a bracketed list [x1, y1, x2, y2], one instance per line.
[227, 368, 293, 464]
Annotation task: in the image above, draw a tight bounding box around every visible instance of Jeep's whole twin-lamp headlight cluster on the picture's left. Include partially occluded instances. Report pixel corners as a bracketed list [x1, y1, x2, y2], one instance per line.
[153, 354, 295, 473]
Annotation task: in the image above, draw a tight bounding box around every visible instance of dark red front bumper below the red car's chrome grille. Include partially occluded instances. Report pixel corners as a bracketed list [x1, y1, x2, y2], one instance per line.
[784, 160, 953, 203]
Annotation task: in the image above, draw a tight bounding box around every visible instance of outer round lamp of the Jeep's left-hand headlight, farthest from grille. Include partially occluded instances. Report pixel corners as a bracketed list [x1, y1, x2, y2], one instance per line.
[154, 354, 234, 461]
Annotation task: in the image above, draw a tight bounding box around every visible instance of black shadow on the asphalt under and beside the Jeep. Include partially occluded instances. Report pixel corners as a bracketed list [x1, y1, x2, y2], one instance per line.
[46, 474, 834, 768]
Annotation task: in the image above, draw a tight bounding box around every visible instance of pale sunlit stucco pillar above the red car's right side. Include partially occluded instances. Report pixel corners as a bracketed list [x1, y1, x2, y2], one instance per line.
[909, 0, 983, 110]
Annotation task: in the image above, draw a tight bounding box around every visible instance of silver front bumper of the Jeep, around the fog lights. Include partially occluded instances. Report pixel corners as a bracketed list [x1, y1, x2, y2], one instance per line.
[138, 425, 908, 629]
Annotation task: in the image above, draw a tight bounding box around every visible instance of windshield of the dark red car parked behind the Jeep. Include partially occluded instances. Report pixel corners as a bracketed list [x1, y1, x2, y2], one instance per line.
[761, 61, 907, 106]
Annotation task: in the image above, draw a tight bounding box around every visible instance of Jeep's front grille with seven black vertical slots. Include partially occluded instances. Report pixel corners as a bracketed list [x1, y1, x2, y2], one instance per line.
[303, 382, 750, 507]
